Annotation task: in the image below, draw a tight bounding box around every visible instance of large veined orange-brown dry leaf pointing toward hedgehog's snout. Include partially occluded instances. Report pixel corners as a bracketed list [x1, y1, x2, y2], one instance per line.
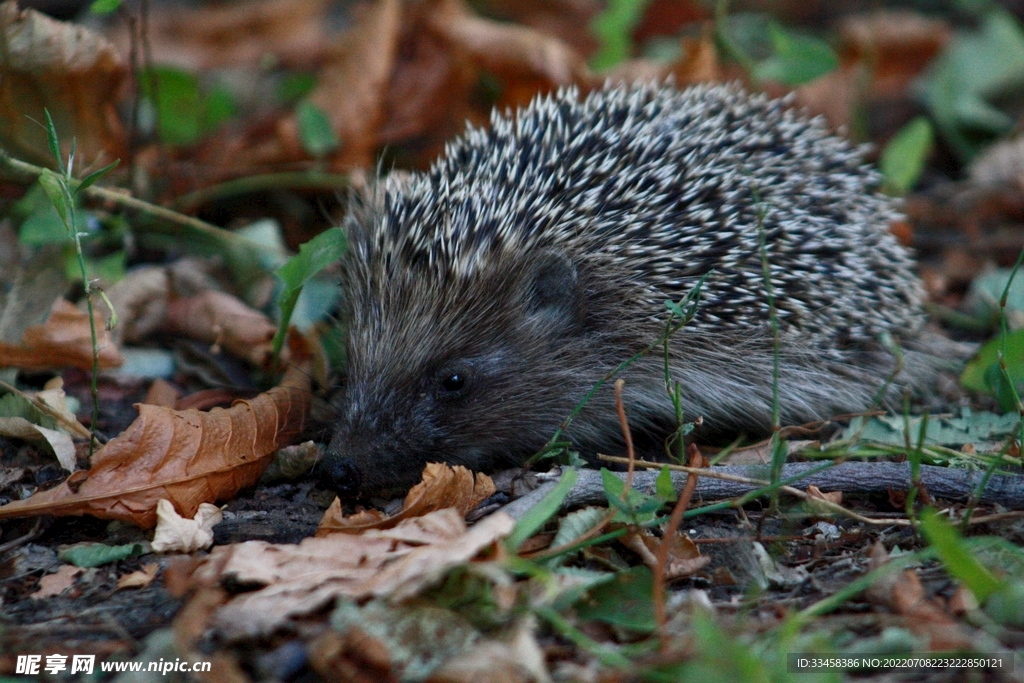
[0, 367, 309, 528]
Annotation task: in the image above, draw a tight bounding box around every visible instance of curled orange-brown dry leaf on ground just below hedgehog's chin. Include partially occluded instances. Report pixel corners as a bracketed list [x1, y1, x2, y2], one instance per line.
[316, 463, 497, 537]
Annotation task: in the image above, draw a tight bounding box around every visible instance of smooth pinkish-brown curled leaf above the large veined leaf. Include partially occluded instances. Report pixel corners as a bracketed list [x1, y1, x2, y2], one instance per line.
[165, 290, 278, 368]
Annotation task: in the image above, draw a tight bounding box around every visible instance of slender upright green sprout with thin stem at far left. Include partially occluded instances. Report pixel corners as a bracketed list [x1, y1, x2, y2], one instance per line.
[39, 111, 120, 458]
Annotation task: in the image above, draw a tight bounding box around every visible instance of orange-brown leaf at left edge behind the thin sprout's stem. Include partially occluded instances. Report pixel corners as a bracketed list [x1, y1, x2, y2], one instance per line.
[0, 299, 124, 370]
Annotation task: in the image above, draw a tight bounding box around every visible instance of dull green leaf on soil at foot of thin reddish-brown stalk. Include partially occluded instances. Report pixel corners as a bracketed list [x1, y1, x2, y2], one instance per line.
[575, 566, 657, 633]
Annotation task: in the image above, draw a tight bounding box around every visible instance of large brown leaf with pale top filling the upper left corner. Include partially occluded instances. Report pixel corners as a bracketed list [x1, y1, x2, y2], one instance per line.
[0, 0, 127, 166]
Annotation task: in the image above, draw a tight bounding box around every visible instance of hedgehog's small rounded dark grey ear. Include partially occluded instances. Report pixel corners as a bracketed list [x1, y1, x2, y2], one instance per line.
[526, 251, 584, 326]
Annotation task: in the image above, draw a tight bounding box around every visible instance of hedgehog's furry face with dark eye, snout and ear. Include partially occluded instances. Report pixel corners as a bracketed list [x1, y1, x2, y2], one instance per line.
[324, 253, 596, 496]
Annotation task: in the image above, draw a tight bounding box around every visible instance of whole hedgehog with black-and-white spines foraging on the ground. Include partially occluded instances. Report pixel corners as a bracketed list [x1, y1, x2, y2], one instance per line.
[322, 84, 927, 497]
